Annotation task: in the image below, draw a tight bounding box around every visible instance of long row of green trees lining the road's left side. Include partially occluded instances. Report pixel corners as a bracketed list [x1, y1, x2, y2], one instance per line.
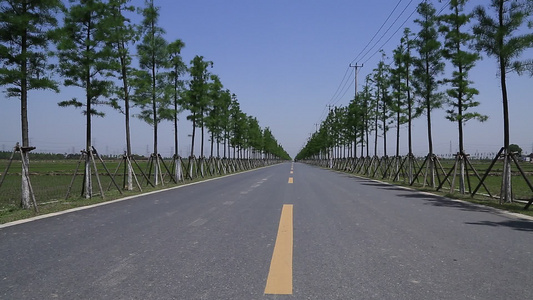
[0, 0, 289, 208]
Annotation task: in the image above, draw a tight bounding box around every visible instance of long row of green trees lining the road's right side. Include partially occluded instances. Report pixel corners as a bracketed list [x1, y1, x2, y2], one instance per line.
[296, 0, 533, 205]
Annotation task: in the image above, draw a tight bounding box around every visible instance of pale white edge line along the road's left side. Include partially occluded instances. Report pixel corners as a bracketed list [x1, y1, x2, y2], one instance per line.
[0, 164, 277, 229]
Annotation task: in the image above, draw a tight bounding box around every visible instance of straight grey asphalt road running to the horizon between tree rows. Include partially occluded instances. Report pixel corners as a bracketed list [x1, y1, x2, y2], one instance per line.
[0, 163, 533, 299]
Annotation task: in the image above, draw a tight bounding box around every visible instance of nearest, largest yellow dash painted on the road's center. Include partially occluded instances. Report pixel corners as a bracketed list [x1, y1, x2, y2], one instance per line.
[265, 204, 293, 295]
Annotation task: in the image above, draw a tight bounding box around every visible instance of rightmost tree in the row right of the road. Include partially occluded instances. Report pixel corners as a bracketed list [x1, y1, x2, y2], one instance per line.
[474, 0, 533, 202]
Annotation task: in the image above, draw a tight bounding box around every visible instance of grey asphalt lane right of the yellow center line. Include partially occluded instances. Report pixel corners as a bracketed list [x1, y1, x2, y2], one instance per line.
[294, 165, 533, 299]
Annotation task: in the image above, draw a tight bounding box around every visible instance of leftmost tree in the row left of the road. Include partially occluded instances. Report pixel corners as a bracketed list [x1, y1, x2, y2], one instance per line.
[0, 0, 62, 209]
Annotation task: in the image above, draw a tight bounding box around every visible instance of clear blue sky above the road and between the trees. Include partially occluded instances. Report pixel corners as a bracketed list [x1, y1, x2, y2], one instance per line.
[0, 0, 533, 157]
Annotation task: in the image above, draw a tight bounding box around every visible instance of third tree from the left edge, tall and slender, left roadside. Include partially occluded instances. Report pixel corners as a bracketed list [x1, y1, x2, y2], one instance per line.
[108, 0, 138, 190]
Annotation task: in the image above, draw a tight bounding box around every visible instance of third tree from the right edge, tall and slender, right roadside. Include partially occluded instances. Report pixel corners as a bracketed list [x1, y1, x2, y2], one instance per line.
[413, 2, 444, 187]
